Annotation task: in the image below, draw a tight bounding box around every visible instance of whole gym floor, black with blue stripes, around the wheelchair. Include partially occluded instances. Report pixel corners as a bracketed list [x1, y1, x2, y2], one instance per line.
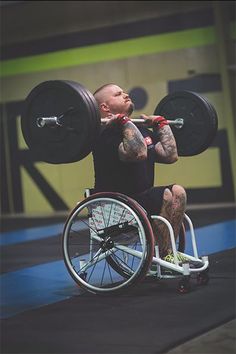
[0, 207, 236, 354]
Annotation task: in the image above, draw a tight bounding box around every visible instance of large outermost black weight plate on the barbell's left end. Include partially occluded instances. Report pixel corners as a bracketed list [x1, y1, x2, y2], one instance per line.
[21, 80, 97, 164]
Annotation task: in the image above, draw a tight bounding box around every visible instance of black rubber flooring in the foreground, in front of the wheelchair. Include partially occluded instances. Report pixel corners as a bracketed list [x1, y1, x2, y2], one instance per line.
[1, 207, 236, 354]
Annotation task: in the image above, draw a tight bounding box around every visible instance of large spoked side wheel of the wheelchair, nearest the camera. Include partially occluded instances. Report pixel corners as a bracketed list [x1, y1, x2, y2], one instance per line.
[62, 192, 154, 294]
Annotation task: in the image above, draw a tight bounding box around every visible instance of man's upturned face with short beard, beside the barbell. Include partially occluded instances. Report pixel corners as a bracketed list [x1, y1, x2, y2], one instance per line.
[103, 85, 134, 116]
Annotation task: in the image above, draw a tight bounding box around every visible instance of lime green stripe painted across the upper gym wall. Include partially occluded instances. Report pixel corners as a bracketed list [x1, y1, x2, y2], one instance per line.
[0, 26, 236, 77]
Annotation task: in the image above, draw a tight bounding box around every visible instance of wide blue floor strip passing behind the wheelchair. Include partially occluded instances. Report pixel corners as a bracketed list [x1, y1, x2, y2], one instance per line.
[0, 220, 236, 318]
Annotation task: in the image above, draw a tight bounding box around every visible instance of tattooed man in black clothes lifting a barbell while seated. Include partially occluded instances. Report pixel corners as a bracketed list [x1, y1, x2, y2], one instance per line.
[93, 84, 186, 262]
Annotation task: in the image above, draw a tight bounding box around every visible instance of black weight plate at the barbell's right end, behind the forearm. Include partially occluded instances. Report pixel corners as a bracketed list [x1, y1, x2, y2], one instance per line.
[154, 91, 217, 156]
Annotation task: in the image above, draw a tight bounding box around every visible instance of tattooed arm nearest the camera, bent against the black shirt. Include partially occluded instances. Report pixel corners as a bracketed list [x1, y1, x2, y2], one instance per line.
[119, 122, 147, 161]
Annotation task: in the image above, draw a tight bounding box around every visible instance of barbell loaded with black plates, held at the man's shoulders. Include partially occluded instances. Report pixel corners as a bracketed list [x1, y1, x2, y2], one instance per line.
[21, 80, 218, 164]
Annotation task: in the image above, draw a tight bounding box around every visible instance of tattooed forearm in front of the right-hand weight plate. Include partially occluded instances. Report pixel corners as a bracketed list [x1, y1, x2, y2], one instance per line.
[155, 126, 178, 163]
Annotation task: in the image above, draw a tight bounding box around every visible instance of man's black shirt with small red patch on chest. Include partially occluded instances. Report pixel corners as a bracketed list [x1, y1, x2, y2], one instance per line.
[93, 126, 157, 196]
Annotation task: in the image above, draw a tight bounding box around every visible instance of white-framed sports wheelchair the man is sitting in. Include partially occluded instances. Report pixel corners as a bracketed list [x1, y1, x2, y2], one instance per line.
[62, 189, 209, 295]
